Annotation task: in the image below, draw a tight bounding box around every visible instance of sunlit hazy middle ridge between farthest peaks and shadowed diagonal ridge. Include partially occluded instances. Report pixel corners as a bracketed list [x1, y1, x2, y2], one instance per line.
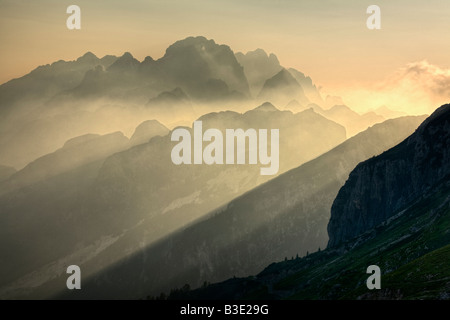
[0, 103, 345, 296]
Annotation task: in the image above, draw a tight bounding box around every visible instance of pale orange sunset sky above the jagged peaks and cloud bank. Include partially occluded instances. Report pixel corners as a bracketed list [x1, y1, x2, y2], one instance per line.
[0, 0, 450, 94]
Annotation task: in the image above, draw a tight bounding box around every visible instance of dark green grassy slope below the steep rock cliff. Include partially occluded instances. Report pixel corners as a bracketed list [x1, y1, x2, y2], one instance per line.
[179, 179, 450, 299]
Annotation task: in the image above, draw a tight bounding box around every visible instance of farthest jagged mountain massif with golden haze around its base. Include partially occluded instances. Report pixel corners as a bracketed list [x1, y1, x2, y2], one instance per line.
[0, 37, 390, 169]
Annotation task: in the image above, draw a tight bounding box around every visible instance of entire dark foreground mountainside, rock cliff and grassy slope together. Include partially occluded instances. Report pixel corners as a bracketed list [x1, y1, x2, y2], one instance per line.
[169, 105, 450, 299]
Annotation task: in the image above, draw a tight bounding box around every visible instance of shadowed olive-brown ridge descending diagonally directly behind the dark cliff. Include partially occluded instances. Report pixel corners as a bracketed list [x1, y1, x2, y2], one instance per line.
[56, 117, 424, 298]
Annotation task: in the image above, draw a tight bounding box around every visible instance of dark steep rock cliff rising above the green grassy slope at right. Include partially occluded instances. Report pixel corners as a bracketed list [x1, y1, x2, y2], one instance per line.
[328, 104, 450, 247]
